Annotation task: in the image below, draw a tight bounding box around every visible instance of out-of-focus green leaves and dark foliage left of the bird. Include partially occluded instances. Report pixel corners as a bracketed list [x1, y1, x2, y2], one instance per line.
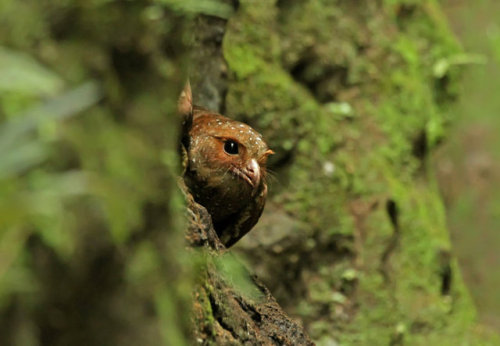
[0, 0, 193, 345]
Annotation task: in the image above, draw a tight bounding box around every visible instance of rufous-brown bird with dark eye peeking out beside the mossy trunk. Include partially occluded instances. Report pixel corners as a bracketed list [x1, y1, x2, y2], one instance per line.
[178, 84, 273, 247]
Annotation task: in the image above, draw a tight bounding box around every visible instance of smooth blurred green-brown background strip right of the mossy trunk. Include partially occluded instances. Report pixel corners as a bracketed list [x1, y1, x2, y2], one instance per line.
[435, 0, 500, 331]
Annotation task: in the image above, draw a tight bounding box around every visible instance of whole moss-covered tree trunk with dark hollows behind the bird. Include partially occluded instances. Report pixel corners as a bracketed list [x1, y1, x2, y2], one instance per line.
[191, 0, 497, 345]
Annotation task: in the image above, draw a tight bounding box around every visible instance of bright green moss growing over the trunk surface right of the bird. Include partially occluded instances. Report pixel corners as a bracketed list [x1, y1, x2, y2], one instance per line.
[224, 0, 494, 345]
